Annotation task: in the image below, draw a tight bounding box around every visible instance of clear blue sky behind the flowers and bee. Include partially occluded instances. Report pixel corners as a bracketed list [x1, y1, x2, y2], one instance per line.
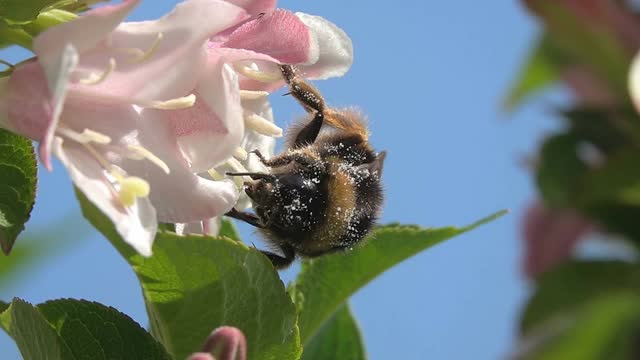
[0, 0, 554, 360]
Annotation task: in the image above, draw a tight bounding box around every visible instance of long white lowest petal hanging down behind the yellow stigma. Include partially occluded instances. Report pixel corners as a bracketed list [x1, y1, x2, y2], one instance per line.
[52, 137, 158, 256]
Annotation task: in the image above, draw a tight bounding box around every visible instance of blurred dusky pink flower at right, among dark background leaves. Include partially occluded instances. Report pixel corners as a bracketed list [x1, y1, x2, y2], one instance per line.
[523, 203, 594, 278]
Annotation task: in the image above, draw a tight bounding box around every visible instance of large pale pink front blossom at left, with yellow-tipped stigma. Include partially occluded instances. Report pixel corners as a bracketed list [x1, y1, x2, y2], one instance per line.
[0, 0, 258, 256]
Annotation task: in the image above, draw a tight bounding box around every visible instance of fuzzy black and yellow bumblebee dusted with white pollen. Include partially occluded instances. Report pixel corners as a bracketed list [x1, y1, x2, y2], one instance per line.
[227, 65, 386, 269]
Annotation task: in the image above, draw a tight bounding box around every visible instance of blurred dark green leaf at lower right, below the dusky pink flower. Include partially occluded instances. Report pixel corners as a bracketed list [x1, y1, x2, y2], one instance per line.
[520, 261, 640, 333]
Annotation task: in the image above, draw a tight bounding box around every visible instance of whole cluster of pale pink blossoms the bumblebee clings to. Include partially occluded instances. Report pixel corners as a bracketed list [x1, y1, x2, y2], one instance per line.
[0, 0, 352, 252]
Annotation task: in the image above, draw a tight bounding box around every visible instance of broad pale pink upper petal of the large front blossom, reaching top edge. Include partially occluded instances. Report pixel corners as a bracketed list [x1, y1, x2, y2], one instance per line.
[69, 0, 248, 104]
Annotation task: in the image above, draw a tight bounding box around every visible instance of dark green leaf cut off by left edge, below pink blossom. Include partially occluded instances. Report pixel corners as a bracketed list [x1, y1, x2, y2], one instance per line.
[0, 129, 38, 255]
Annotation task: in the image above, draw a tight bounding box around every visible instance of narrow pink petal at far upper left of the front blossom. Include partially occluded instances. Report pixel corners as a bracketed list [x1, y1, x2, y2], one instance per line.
[33, 0, 140, 63]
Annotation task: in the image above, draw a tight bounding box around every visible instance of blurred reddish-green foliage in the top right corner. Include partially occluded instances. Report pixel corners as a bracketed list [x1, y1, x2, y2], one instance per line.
[524, 0, 640, 107]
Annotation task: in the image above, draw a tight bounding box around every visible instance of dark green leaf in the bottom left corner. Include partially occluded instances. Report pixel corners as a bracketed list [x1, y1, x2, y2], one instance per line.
[0, 299, 171, 360]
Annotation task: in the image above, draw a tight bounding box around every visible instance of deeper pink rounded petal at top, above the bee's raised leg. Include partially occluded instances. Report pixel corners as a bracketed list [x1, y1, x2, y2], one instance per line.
[221, 10, 318, 64]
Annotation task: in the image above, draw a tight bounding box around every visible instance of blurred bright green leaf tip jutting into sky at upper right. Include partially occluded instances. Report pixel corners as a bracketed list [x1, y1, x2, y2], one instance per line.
[504, 33, 561, 112]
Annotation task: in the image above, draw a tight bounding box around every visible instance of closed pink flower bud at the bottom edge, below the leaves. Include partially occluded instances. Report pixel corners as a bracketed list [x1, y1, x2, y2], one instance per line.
[187, 326, 247, 360]
